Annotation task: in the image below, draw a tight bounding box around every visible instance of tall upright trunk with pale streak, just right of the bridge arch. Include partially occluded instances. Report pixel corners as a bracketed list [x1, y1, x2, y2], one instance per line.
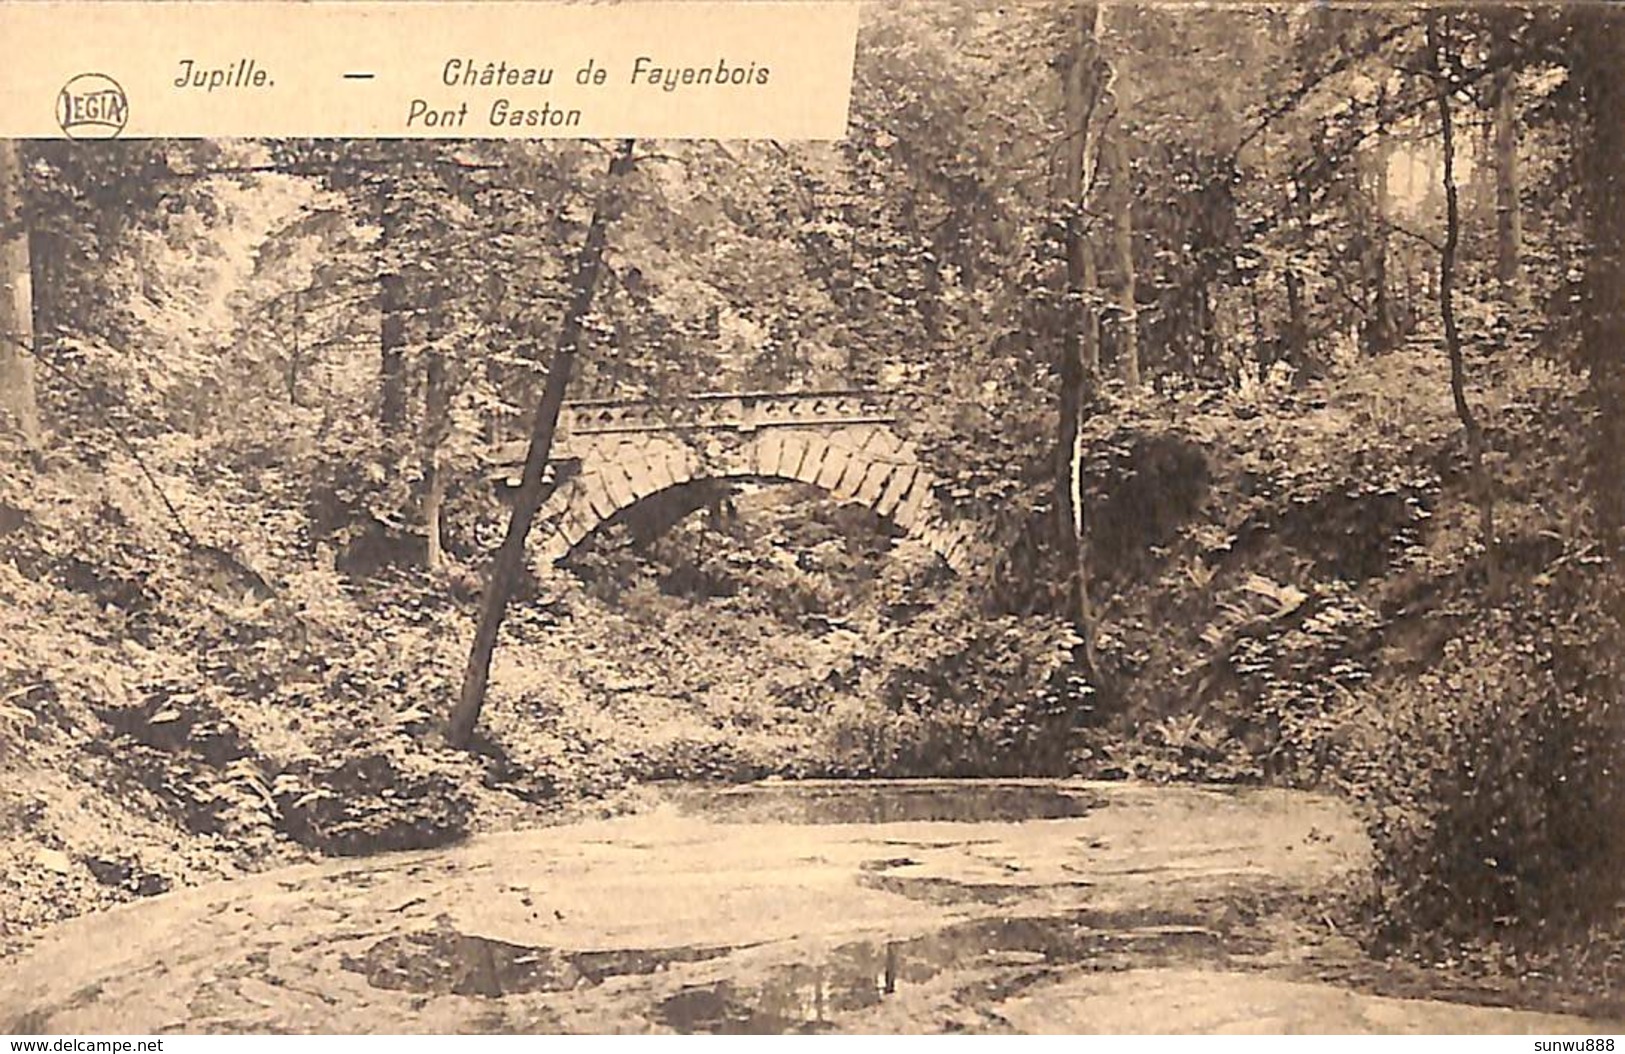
[1056, 3, 1105, 676]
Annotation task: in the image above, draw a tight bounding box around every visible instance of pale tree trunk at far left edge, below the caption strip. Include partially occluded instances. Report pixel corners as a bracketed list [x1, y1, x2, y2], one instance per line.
[0, 140, 41, 455]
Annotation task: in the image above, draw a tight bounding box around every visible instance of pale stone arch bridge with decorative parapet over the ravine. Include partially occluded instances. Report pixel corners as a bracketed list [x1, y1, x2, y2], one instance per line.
[501, 391, 972, 572]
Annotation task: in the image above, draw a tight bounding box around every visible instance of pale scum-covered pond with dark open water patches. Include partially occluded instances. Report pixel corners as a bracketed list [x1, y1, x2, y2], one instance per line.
[0, 781, 1622, 1033]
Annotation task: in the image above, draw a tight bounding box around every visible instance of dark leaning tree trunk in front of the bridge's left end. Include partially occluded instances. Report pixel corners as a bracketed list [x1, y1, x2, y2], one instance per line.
[445, 140, 632, 747]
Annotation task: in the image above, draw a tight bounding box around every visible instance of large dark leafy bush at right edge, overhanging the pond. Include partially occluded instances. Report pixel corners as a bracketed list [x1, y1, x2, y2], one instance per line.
[1349, 568, 1625, 947]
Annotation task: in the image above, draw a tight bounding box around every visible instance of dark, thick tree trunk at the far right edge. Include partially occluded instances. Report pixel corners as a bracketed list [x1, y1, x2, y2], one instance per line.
[1571, 5, 1625, 552]
